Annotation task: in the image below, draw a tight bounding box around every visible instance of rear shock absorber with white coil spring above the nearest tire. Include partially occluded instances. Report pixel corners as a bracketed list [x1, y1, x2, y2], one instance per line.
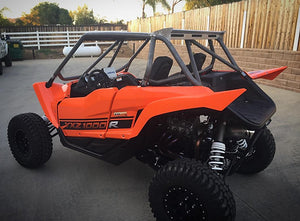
[208, 121, 226, 171]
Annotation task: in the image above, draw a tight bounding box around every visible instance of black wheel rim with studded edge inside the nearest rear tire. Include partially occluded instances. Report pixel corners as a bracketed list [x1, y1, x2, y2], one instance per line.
[163, 187, 207, 221]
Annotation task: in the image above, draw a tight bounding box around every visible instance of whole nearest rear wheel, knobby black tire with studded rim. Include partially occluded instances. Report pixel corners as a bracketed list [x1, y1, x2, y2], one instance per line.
[149, 159, 236, 221]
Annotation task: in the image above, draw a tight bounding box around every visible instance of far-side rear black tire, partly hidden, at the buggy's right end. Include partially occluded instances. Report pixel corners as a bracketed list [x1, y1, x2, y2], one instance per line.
[237, 128, 276, 174]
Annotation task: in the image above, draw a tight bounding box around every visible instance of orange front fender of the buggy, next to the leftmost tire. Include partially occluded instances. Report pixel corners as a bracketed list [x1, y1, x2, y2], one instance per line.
[33, 82, 70, 128]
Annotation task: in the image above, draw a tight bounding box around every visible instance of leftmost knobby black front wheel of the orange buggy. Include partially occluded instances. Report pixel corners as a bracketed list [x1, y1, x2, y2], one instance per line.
[7, 113, 52, 168]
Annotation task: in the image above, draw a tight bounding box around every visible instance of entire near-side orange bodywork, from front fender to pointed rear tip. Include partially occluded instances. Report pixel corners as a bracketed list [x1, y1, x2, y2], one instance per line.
[33, 82, 246, 139]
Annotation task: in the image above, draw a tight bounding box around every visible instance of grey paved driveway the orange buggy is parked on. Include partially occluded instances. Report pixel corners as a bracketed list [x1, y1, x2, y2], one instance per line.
[0, 59, 300, 221]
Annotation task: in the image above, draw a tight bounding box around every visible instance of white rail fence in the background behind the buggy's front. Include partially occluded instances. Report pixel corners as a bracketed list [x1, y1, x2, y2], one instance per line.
[2, 31, 113, 50]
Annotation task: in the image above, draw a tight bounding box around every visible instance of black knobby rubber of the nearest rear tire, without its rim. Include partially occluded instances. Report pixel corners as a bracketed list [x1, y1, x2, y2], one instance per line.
[149, 159, 236, 221]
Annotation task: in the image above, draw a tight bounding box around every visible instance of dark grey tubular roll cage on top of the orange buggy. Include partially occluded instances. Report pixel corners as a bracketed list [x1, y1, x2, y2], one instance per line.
[46, 28, 244, 88]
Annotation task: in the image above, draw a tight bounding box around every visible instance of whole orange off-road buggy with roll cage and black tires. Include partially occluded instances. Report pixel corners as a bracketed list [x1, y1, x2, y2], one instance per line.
[8, 28, 286, 221]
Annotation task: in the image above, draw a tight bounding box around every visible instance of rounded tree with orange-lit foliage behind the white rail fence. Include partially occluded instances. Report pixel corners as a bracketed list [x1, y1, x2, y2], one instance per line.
[19, 2, 72, 25]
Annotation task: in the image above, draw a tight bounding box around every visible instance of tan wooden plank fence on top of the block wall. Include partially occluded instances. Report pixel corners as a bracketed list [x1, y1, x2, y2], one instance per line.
[128, 0, 300, 51]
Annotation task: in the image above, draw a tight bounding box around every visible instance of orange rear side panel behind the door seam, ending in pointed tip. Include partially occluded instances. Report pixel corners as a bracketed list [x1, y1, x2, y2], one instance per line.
[106, 86, 246, 139]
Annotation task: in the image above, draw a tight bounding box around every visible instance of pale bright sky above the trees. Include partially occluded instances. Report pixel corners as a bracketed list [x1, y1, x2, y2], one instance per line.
[0, 0, 184, 21]
